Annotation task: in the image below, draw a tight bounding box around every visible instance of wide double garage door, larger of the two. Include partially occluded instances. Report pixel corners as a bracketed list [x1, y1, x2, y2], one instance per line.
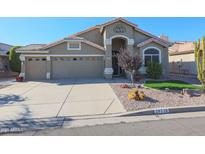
[52, 57, 104, 79]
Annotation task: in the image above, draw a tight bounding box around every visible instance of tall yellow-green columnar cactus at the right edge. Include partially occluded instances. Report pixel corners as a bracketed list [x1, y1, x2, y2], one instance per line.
[194, 37, 205, 89]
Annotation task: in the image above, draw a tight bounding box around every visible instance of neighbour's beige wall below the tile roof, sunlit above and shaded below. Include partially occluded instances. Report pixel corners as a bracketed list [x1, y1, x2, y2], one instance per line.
[169, 53, 197, 75]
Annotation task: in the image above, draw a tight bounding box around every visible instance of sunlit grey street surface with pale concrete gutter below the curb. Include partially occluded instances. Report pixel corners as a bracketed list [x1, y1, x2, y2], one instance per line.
[2, 112, 205, 136]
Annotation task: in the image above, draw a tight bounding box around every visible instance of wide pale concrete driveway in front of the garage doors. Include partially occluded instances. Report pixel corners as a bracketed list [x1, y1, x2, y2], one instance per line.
[0, 79, 125, 121]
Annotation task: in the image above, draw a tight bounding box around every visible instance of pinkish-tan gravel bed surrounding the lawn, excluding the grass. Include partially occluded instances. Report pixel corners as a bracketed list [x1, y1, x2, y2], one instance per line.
[110, 83, 205, 111]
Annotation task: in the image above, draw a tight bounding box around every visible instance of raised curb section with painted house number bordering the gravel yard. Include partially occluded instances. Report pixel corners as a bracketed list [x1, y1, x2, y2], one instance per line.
[120, 105, 205, 116]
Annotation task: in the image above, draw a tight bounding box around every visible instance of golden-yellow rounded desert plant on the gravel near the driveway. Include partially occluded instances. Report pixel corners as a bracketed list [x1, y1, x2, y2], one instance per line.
[128, 88, 145, 100]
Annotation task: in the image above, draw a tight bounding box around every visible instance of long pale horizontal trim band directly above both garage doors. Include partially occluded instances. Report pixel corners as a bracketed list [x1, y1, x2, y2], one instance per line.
[23, 54, 105, 57]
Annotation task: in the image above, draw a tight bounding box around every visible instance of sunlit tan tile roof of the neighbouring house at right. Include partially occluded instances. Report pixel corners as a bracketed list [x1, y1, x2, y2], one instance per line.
[169, 42, 194, 55]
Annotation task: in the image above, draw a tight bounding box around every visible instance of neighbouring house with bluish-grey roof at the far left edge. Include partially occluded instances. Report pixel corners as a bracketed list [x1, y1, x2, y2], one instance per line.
[0, 43, 12, 73]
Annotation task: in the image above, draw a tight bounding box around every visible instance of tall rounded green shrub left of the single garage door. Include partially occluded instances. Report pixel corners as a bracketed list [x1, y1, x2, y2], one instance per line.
[9, 46, 21, 73]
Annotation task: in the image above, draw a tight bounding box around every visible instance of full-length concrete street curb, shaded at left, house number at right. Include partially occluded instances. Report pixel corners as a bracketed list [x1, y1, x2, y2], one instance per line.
[0, 105, 205, 135]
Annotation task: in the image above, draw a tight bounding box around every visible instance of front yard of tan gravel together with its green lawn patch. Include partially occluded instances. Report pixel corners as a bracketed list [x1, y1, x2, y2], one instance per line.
[110, 80, 205, 111]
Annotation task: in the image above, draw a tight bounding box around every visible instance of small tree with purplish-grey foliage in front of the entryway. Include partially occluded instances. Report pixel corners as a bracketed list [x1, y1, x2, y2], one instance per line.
[117, 48, 142, 86]
